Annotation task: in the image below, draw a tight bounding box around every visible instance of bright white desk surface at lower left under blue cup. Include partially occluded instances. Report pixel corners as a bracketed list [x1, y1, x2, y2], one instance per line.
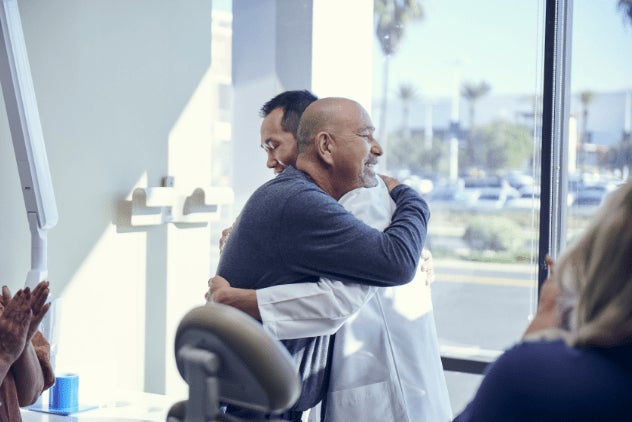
[21, 392, 182, 422]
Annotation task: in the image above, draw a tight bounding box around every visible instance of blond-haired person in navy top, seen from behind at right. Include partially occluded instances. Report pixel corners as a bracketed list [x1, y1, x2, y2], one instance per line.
[455, 179, 632, 422]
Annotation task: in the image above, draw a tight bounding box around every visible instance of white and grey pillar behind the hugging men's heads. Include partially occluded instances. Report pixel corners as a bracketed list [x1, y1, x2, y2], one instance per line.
[233, 0, 377, 206]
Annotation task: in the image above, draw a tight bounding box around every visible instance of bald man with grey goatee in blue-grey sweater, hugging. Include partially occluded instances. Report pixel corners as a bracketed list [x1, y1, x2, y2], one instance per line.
[217, 98, 429, 420]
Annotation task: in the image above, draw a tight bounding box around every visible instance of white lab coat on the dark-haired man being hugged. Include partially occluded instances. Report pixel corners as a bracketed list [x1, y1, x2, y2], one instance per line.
[257, 179, 452, 422]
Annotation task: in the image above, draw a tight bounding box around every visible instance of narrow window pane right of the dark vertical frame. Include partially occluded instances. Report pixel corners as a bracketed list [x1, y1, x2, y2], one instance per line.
[567, 0, 632, 242]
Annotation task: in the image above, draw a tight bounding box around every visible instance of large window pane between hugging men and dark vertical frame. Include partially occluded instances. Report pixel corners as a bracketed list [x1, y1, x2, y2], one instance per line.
[373, 0, 544, 411]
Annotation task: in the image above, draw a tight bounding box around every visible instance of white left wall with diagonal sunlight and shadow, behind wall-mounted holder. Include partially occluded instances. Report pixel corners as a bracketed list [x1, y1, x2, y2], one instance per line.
[0, 0, 216, 393]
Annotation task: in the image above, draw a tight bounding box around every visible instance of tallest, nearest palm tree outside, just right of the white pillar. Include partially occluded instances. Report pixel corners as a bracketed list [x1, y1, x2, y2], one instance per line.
[375, 0, 423, 168]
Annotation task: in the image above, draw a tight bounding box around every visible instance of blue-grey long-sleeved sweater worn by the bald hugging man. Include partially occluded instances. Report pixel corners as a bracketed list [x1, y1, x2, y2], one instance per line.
[217, 167, 430, 411]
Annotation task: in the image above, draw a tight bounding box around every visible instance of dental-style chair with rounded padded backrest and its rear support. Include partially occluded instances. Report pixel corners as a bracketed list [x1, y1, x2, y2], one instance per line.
[167, 303, 301, 422]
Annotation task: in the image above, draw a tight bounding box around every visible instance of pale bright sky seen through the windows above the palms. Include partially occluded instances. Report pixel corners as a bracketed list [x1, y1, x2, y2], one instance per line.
[373, 0, 632, 97]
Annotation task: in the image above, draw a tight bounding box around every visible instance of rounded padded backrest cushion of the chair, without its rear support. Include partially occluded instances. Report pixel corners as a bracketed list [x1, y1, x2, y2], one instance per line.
[175, 303, 301, 413]
